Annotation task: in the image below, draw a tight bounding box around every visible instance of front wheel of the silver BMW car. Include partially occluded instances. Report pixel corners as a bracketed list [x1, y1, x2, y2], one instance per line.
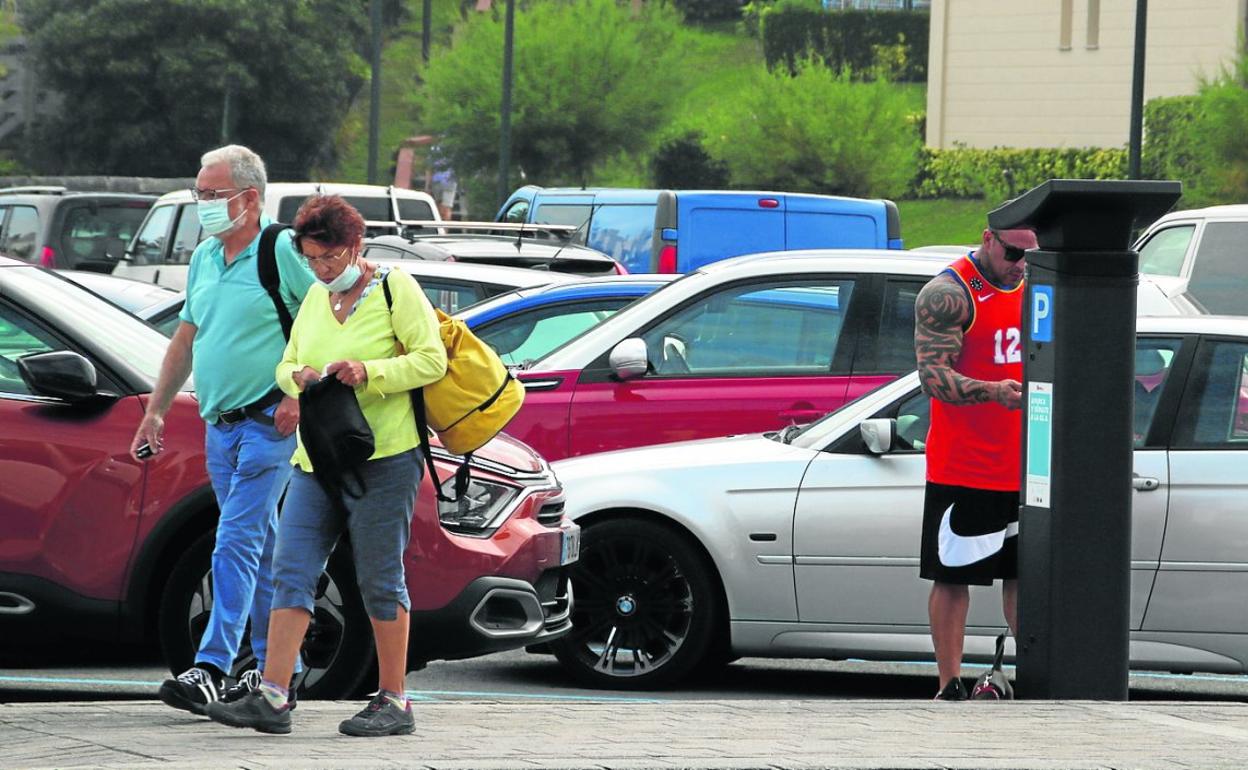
[550, 519, 719, 690]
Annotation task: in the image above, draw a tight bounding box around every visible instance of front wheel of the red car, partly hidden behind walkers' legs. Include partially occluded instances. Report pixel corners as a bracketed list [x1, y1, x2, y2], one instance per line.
[157, 532, 376, 700]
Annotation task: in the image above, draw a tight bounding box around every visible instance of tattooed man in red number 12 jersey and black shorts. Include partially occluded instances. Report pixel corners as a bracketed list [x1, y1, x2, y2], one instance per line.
[915, 224, 1036, 700]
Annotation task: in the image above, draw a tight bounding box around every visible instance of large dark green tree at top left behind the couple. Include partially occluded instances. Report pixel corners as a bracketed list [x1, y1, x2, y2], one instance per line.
[21, 0, 368, 180]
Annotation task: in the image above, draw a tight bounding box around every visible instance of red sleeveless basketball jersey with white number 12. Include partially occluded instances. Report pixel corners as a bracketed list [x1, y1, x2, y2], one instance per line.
[927, 256, 1023, 492]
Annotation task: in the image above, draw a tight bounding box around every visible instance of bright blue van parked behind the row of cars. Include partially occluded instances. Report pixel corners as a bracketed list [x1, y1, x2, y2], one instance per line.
[495, 185, 902, 273]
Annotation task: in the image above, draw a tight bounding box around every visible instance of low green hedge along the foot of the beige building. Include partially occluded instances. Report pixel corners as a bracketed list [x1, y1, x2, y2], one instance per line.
[911, 147, 1127, 201]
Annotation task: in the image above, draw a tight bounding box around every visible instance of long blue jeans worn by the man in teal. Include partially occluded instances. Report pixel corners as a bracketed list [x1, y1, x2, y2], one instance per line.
[195, 406, 301, 673]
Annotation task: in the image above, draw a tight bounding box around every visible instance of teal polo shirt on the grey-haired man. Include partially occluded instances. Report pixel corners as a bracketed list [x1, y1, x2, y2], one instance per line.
[181, 217, 316, 423]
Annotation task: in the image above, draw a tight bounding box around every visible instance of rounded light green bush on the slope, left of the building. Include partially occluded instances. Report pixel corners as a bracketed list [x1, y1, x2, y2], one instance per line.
[705, 61, 920, 197]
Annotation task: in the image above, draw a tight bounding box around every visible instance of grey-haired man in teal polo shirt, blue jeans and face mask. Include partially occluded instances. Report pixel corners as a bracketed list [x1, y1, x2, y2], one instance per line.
[131, 145, 316, 715]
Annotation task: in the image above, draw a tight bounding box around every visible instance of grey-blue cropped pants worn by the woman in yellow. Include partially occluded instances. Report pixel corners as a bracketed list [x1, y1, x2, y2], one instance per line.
[272, 449, 423, 620]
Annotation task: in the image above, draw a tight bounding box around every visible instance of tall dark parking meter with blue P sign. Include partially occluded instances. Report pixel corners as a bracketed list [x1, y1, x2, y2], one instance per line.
[988, 180, 1182, 700]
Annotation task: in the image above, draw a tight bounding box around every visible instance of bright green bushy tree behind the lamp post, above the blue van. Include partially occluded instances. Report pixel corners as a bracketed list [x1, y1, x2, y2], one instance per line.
[423, 0, 680, 200]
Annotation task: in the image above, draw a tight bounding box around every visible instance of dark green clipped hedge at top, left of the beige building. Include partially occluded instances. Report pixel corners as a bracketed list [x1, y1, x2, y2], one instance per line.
[761, 6, 931, 82]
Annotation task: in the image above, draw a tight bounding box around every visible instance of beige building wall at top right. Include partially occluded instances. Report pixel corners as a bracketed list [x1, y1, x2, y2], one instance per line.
[927, 0, 1248, 149]
